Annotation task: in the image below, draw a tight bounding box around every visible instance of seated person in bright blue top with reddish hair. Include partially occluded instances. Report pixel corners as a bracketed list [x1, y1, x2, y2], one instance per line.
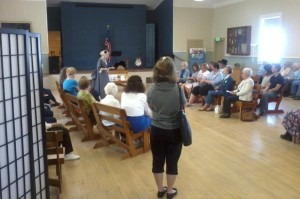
[63, 67, 78, 96]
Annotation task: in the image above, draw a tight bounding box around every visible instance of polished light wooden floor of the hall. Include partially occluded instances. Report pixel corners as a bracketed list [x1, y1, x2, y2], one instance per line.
[50, 92, 300, 199]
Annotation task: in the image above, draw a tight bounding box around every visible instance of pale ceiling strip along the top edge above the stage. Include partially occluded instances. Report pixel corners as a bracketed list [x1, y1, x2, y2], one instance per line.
[46, 0, 246, 9]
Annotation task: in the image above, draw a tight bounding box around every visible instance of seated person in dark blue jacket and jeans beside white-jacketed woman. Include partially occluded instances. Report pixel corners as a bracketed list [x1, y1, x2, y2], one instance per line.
[199, 66, 234, 111]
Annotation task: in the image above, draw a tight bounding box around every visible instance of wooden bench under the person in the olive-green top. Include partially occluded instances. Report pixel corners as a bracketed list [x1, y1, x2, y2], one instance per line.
[65, 93, 100, 142]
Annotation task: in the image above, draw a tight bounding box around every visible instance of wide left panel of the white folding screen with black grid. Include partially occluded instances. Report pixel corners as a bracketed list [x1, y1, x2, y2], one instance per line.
[0, 31, 31, 198]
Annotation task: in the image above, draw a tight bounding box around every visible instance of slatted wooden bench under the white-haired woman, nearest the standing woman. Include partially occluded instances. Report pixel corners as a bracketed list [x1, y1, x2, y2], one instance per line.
[93, 102, 150, 158]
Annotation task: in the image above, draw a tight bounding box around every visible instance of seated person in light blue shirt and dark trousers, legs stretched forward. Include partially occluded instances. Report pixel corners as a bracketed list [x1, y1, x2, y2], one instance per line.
[186, 62, 223, 106]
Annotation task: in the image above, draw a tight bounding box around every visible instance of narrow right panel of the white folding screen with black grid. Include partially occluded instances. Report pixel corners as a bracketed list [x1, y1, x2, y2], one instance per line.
[29, 33, 46, 198]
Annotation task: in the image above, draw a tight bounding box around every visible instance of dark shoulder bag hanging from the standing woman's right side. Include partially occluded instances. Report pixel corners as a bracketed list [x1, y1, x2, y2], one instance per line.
[178, 86, 192, 146]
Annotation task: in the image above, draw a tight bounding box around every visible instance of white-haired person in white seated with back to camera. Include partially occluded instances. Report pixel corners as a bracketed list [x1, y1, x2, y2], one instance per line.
[100, 82, 120, 126]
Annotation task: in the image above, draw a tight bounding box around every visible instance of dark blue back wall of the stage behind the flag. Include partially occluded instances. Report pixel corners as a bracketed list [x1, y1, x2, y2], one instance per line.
[61, 2, 146, 70]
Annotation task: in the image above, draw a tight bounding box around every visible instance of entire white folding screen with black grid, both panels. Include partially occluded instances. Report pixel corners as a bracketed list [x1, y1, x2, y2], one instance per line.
[0, 29, 48, 199]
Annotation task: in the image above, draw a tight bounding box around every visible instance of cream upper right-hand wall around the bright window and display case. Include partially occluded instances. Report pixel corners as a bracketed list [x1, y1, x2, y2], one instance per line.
[212, 0, 300, 58]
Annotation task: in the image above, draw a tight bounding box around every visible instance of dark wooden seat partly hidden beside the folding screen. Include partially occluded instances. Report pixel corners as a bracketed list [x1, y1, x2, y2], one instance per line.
[46, 131, 64, 193]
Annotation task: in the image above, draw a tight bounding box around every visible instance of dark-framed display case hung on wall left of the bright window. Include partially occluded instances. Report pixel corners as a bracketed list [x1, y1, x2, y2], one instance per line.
[227, 26, 251, 55]
